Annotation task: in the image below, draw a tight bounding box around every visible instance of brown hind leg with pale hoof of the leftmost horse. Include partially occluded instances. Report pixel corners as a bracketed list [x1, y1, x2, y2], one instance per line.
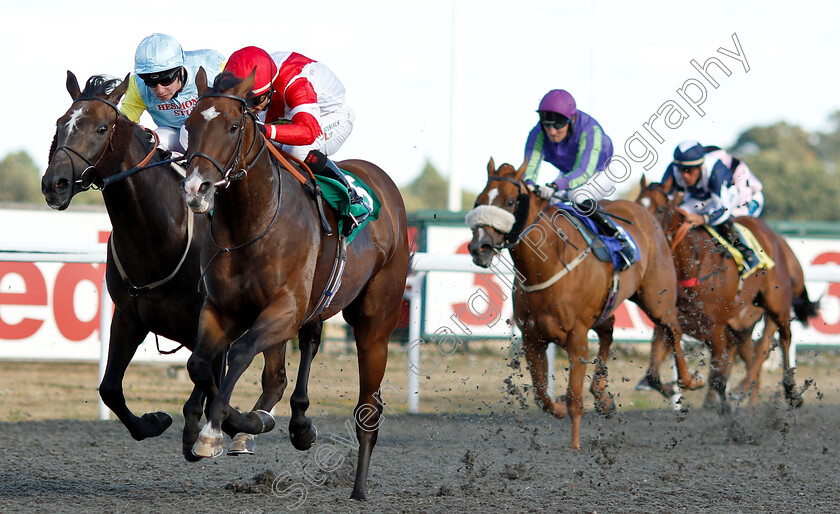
[227, 342, 288, 455]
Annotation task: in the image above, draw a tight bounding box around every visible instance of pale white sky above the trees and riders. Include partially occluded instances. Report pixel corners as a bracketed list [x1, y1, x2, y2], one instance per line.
[0, 0, 840, 209]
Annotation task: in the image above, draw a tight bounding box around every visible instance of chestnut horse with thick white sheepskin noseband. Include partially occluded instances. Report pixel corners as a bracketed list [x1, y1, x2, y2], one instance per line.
[468, 159, 704, 449]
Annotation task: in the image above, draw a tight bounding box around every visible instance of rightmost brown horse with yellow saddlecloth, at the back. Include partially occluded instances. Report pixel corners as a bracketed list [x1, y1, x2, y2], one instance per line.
[637, 182, 818, 413]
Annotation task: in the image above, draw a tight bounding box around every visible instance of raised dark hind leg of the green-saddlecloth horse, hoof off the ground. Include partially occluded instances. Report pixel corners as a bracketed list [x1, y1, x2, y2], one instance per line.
[289, 321, 323, 451]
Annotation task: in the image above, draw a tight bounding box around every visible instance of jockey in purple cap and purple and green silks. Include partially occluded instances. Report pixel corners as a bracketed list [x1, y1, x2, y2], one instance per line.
[525, 89, 635, 270]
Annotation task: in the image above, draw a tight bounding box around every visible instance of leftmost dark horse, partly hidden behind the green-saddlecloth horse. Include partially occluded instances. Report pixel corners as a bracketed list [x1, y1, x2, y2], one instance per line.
[41, 71, 287, 459]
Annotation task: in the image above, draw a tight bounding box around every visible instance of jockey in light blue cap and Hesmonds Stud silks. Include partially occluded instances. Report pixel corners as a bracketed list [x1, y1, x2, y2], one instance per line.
[120, 34, 225, 153]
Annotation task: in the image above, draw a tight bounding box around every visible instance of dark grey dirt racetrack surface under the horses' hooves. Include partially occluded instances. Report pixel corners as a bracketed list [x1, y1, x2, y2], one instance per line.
[0, 399, 840, 513]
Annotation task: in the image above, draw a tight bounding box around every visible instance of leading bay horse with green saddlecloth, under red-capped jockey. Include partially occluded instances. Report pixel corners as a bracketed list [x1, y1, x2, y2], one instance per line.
[184, 70, 409, 499]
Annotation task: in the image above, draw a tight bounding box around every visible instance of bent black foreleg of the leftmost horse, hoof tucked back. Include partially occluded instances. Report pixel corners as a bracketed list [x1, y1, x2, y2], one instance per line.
[99, 310, 172, 441]
